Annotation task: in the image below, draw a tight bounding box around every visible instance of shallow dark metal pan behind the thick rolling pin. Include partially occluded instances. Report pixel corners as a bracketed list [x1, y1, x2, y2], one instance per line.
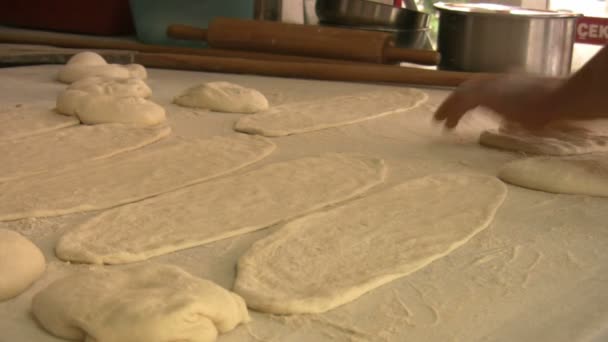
[316, 0, 431, 30]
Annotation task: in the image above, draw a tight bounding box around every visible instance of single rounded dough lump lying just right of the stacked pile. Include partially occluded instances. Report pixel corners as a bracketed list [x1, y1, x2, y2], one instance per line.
[173, 82, 268, 114]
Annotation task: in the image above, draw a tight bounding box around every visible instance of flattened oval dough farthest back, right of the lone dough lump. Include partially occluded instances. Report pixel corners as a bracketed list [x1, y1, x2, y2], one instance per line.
[235, 89, 427, 137]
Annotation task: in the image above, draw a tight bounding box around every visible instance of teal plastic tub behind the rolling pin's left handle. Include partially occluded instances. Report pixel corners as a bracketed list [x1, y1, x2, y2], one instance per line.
[129, 0, 254, 47]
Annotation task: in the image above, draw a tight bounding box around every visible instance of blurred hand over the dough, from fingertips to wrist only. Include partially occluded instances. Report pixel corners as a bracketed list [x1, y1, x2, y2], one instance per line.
[434, 75, 563, 129]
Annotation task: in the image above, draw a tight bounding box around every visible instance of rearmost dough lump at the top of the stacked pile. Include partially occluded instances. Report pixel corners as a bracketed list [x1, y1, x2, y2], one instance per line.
[57, 51, 147, 83]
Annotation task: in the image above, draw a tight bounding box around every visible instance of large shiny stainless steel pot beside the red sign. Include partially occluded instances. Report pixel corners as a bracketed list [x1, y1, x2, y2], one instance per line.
[435, 2, 579, 76]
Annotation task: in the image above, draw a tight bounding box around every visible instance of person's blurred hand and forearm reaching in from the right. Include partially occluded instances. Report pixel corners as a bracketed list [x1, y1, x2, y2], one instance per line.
[435, 47, 608, 129]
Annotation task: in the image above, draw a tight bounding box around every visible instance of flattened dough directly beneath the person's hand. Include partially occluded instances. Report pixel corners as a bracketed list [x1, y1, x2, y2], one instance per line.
[479, 124, 608, 156]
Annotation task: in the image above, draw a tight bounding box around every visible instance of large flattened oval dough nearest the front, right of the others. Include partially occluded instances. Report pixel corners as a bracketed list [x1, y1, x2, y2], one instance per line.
[234, 175, 507, 314]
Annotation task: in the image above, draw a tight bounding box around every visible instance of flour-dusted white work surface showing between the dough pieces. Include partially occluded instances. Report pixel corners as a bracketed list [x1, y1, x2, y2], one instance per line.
[0, 66, 608, 342]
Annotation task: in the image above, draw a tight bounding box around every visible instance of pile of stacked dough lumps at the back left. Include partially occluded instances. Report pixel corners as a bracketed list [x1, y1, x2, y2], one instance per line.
[56, 52, 166, 126]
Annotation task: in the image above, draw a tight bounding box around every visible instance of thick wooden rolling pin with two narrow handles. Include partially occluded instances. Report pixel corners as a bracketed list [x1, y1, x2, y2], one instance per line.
[167, 18, 439, 65]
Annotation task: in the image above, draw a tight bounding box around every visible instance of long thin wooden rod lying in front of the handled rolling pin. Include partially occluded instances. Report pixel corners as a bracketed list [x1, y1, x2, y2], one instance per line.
[135, 53, 484, 86]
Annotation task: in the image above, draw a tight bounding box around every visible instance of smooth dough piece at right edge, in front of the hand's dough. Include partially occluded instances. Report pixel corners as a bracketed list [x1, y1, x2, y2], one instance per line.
[498, 154, 608, 197]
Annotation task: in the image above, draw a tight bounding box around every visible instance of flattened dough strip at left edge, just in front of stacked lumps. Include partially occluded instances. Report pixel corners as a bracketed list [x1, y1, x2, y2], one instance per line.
[0, 124, 171, 182]
